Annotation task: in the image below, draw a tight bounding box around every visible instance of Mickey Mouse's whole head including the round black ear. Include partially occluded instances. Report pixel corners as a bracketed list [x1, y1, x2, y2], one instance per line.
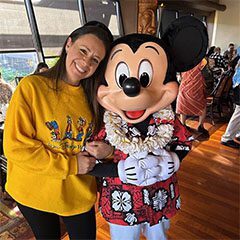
[98, 16, 208, 123]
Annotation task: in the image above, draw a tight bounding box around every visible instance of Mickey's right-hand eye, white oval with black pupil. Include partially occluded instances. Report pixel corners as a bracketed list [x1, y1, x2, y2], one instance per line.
[139, 60, 153, 87]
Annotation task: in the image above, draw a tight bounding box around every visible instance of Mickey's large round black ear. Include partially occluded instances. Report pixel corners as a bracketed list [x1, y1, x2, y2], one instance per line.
[162, 16, 208, 72]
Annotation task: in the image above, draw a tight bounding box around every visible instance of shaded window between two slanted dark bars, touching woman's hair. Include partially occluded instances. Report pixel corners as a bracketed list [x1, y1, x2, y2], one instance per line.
[32, 0, 81, 57]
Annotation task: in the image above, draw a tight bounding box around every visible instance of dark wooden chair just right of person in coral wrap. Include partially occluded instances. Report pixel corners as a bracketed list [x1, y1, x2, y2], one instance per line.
[207, 69, 234, 125]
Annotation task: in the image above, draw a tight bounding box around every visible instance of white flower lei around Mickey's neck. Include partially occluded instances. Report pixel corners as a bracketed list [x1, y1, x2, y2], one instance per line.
[104, 108, 175, 155]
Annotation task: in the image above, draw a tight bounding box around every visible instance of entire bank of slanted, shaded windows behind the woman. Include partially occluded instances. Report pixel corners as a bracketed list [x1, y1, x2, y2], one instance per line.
[0, 0, 123, 83]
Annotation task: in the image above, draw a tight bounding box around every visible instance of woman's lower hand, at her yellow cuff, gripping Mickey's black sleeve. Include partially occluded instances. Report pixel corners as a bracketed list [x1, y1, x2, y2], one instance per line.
[77, 151, 96, 174]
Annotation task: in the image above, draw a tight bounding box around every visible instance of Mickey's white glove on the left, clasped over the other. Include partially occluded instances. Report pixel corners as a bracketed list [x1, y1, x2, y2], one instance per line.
[118, 152, 161, 186]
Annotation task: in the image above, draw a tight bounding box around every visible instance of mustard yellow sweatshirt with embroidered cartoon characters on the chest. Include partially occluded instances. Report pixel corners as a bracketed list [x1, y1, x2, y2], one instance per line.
[4, 75, 96, 216]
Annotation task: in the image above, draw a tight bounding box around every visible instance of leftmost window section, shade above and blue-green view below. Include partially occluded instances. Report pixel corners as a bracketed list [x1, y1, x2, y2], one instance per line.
[0, 0, 37, 86]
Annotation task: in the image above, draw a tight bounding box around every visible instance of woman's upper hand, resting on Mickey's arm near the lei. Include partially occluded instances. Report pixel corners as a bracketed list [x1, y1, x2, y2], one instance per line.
[86, 141, 113, 159]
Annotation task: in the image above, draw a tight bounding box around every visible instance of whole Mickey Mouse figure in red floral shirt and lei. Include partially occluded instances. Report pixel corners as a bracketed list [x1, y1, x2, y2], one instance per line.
[88, 16, 208, 240]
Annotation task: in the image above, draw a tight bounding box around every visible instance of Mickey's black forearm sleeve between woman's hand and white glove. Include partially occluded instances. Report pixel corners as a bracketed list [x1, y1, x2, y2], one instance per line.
[88, 162, 118, 177]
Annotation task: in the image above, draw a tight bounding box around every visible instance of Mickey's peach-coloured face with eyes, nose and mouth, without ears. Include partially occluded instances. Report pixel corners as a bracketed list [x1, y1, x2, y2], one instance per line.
[98, 42, 178, 123]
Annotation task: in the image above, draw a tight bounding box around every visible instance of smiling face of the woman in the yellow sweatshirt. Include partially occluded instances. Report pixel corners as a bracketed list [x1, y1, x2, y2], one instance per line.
[66, 34, 106, 86]
